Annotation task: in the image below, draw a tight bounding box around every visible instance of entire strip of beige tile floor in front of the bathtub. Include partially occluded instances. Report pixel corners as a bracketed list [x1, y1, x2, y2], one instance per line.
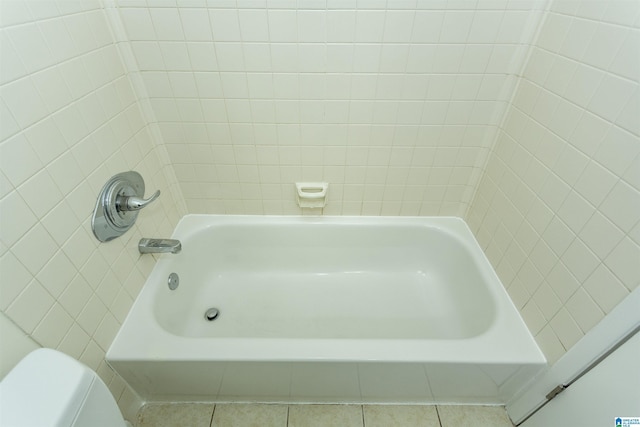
[136, 403, 513, 427]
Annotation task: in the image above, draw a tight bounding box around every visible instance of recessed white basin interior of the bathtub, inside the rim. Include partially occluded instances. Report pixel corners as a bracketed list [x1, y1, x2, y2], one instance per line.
[154, 222, 496, 339]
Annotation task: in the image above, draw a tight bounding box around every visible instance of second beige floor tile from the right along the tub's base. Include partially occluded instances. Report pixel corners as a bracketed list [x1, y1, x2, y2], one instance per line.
[363, 405, 440, 427]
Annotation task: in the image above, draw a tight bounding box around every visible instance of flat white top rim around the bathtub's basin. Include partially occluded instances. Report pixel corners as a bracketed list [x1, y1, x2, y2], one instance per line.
[106, 214, 546, 365]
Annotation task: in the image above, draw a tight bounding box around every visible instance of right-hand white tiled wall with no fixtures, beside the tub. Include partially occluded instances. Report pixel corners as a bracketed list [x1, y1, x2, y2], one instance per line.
[468, 0, 640, 363]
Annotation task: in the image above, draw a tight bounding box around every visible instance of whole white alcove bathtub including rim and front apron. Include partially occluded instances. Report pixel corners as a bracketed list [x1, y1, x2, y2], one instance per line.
[107, 215, 546, 404]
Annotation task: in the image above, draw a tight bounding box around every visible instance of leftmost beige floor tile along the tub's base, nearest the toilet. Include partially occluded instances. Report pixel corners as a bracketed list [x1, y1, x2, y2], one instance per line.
[136, 403, 214, 427]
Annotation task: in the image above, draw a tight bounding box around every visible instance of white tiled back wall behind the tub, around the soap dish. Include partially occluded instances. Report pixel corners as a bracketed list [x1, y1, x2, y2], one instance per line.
[116, 0, 546, 215]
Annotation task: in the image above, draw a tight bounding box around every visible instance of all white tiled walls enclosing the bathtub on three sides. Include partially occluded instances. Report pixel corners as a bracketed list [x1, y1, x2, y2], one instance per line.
[0, 0, 640, 422]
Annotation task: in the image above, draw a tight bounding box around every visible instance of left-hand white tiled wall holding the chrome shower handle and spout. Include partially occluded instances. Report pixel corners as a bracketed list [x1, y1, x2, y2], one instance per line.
[0, 0, 186, 418]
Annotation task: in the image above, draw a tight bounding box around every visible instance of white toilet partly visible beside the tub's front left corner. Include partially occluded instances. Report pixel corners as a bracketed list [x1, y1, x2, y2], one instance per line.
[0, 348, 128, 427]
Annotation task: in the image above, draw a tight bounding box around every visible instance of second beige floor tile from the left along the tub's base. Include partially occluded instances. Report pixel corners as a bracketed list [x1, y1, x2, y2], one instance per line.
[211, 403, 288, 427]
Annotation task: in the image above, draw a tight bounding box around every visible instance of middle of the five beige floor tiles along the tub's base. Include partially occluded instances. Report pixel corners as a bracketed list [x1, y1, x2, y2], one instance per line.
[288, 405, 364, 427]
